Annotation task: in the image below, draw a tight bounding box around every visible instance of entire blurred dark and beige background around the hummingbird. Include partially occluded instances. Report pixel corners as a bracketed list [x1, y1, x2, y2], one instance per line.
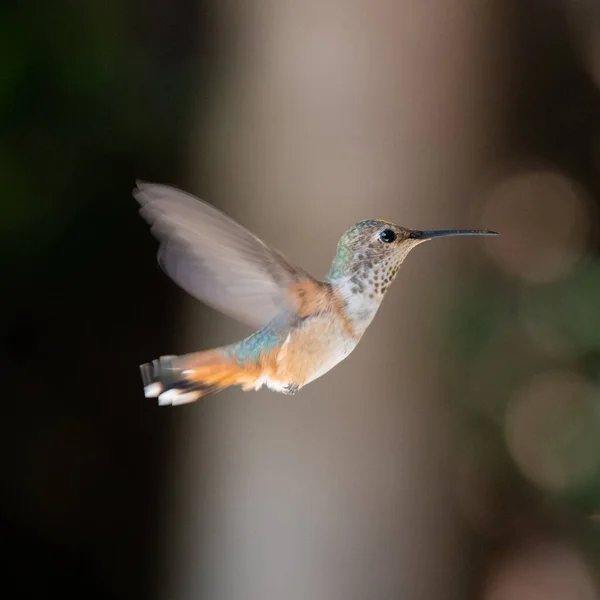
[0, 0, 600, 600]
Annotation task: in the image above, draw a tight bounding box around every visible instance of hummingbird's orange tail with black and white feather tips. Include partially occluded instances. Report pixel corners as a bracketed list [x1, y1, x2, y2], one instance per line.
[140, 350, 257, 405]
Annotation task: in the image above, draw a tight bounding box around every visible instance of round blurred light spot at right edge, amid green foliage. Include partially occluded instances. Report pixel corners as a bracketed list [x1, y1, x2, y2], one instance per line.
[505, 371, 600, 490]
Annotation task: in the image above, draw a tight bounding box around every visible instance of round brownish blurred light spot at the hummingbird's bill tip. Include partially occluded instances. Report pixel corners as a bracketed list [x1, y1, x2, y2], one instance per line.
[483, 170, 590, 282]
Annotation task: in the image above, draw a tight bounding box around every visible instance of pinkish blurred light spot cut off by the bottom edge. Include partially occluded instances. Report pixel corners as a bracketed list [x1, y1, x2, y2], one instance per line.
[483, 544, 597, 600]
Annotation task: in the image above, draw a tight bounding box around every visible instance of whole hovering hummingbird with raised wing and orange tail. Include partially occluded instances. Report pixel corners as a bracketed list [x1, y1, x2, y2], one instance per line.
[133, 181, 498, 405]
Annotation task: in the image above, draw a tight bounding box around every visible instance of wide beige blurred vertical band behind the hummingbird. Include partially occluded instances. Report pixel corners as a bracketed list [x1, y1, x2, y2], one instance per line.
[163, 0, 510, 600]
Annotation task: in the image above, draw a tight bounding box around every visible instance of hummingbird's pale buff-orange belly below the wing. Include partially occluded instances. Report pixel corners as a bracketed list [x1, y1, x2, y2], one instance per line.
[267, 314, 360, 387]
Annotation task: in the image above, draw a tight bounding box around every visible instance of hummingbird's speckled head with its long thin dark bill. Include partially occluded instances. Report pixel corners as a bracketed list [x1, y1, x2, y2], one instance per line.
[327, 219, 498, 293]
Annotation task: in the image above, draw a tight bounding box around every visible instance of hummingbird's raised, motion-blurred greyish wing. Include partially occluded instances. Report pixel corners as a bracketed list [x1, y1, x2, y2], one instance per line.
[133, 181, 311, 327]
